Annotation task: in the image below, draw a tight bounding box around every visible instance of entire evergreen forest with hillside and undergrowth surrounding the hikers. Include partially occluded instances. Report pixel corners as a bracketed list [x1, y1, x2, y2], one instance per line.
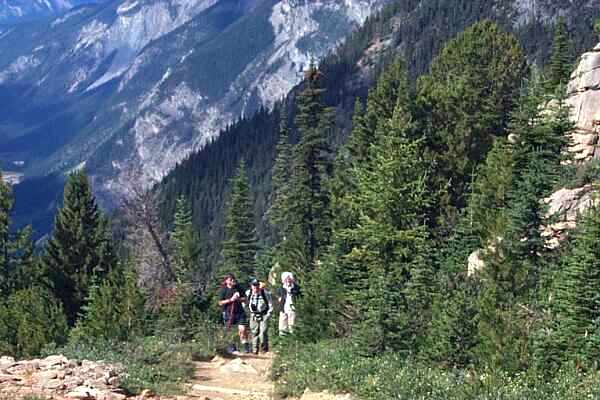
[0, 1, 600, 399]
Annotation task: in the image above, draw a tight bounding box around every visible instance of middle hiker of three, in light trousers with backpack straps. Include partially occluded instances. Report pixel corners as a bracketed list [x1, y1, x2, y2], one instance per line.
[246, 279, 273, 354]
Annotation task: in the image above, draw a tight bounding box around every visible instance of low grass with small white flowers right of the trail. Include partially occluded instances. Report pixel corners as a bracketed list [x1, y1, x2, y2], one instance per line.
[272, 341, 600, 400]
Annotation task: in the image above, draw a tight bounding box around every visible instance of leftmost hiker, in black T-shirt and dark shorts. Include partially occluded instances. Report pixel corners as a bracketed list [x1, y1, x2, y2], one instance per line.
[219, 274, 250, 353]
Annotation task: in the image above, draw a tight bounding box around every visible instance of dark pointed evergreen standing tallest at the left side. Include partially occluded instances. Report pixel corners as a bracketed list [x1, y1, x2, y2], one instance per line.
[42, 171, 115, 325]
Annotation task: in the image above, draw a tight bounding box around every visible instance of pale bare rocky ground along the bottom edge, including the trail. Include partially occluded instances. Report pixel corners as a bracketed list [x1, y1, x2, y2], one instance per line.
[0, 353, 352, 400]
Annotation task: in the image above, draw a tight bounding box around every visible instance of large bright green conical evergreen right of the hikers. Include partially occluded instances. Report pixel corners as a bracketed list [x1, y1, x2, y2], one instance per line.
[338, 101, 432, 355]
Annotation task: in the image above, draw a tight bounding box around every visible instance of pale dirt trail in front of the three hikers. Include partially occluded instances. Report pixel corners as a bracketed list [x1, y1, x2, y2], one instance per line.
[188, 353, 273, 400]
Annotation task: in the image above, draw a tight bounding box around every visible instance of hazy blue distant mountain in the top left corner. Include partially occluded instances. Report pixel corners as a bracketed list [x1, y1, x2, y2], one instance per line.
[0, 0, 101, 25]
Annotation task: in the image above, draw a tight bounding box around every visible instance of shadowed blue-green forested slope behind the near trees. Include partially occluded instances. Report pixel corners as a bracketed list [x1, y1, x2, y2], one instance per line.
[159, 0, 598, 274]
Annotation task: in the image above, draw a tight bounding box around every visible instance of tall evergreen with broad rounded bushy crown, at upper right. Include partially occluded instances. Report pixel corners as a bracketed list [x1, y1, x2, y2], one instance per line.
[417, 21, 526, 229]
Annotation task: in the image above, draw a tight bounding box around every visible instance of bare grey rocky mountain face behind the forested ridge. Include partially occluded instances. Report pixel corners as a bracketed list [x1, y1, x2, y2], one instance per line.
[0, 0, 386, 206]
